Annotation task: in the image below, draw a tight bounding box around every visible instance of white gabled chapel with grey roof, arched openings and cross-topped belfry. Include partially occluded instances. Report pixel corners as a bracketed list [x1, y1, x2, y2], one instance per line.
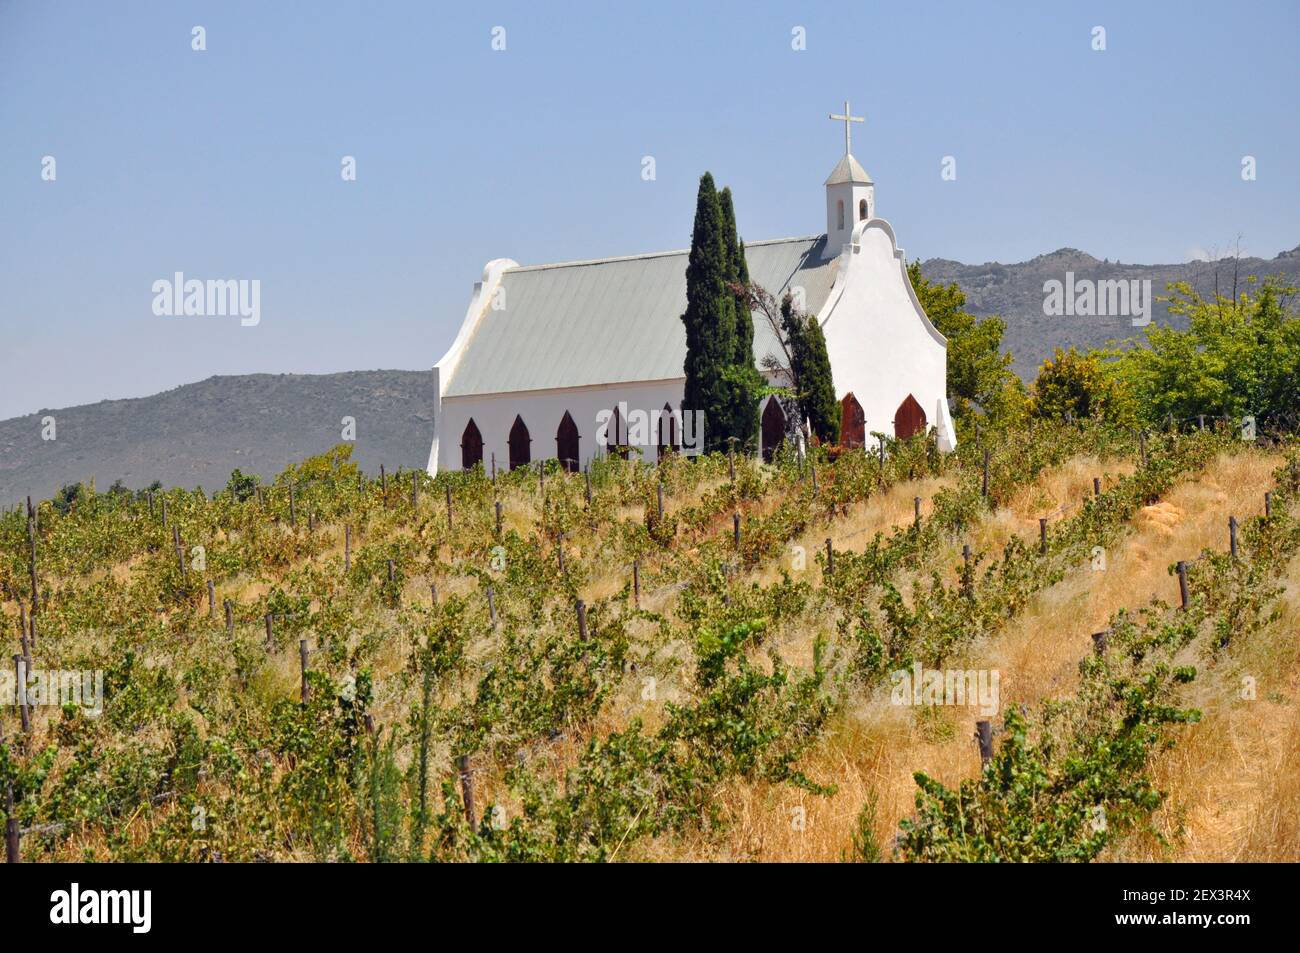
[428, 103, 957, 475]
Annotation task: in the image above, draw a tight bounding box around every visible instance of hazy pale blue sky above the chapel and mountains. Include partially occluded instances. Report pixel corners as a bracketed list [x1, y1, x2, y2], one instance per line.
[0, 0, 1300, 417]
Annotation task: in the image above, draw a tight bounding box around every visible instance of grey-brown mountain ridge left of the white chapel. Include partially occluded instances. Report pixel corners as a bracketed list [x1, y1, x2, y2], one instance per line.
[0, 371, 436, 503]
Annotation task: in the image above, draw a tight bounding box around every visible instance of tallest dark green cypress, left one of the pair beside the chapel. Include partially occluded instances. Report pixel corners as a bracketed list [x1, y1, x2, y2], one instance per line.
[681, 172, 736, 451]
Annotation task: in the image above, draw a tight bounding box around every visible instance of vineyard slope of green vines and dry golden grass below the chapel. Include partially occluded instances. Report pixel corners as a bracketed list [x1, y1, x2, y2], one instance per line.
[0, 423, 1300, 861]
